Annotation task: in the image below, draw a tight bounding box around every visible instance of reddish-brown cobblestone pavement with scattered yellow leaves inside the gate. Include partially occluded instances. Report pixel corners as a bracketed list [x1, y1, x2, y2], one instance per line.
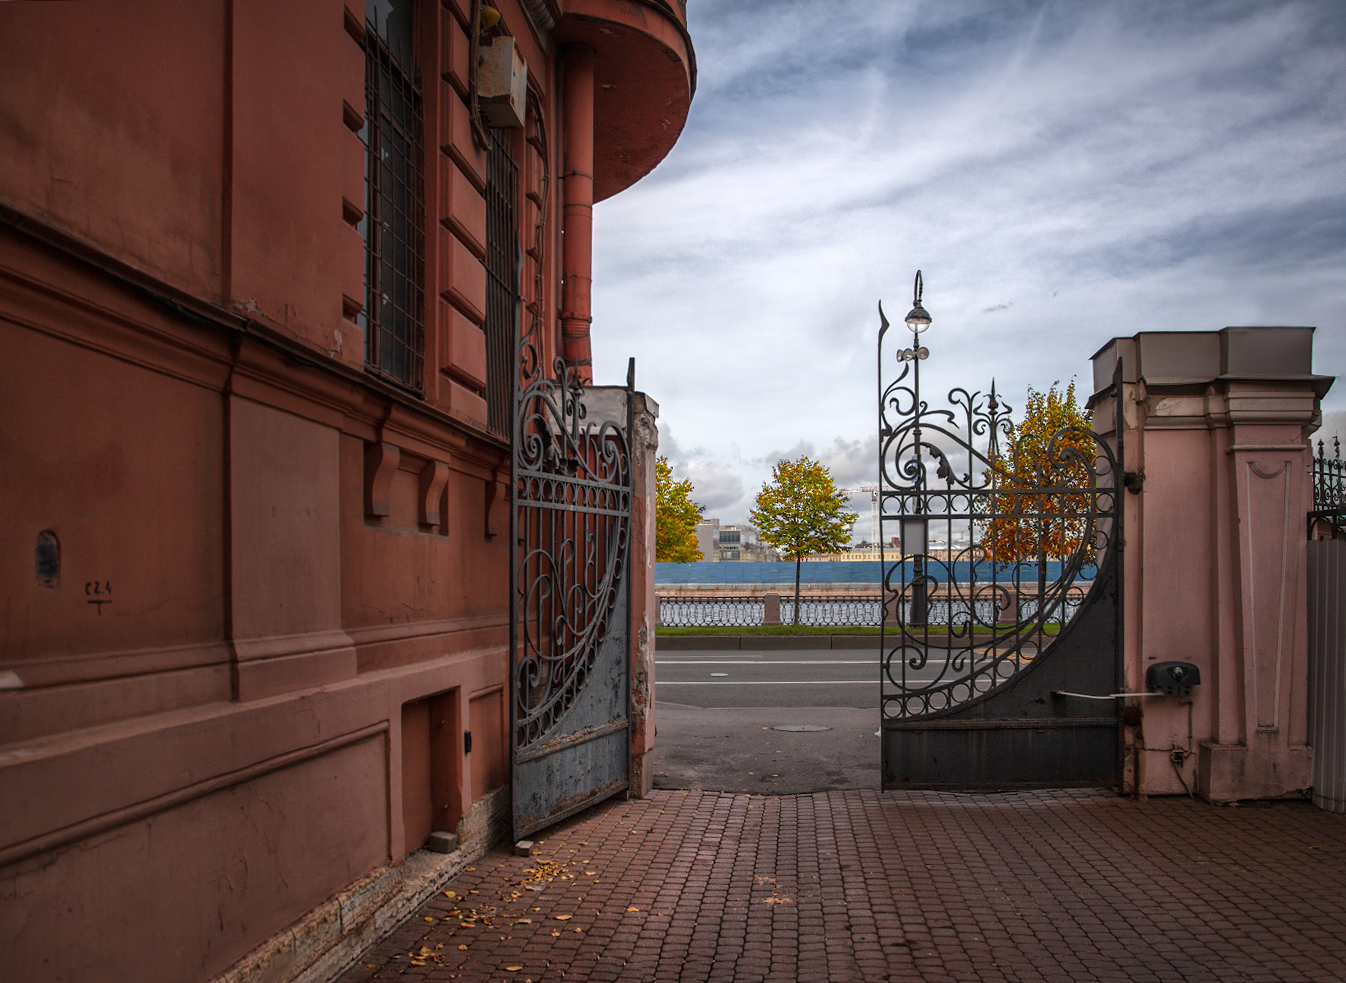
[343, 790, 1346, 983]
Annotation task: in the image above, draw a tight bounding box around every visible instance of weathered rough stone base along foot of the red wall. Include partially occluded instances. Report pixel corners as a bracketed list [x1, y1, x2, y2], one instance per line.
[213, 786, 510, 983]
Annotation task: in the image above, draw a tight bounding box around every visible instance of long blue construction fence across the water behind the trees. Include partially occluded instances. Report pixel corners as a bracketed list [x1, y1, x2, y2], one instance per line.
[654, 560, 1096, 587]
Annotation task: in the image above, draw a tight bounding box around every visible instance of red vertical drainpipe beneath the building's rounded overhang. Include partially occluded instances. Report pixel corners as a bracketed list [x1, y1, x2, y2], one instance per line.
[561, 44, 594, 385]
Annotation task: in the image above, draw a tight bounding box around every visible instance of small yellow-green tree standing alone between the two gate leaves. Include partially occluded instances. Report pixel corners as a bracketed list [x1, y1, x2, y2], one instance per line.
[748, 458, 856, 625]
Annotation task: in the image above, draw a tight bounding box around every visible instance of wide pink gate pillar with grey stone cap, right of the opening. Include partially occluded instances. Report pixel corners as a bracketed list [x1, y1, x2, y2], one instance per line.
[1090, 327, 1333, 801]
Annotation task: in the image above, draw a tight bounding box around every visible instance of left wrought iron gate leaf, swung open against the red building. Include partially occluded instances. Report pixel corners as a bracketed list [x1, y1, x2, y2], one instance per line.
[510, 329, 634, 839]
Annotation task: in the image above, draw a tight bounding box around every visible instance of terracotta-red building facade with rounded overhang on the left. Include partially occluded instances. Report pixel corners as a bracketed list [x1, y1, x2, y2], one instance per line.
[0, 0, 696, 983]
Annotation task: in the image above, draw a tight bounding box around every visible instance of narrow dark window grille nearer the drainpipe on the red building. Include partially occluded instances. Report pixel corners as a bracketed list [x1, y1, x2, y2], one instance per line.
[485, 129, 520, 434]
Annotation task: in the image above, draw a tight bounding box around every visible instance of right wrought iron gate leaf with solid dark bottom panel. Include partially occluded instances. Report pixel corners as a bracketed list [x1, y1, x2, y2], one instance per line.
[879, 272, 1123, 789]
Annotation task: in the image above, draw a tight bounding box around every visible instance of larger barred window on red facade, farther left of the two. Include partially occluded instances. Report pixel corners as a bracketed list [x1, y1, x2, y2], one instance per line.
[359, 0, 425, 392]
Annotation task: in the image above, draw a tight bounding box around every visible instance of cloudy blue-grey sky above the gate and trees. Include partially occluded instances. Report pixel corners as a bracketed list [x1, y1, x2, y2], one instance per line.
[594, 0, 1346, 535]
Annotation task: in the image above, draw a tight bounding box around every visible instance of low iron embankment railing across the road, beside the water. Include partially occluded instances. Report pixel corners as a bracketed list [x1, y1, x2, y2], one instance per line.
[660, 583, 1088, 628]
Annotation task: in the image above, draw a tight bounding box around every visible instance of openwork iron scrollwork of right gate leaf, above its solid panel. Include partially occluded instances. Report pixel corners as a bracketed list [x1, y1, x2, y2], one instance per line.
[878, 282, 1123, 719]
